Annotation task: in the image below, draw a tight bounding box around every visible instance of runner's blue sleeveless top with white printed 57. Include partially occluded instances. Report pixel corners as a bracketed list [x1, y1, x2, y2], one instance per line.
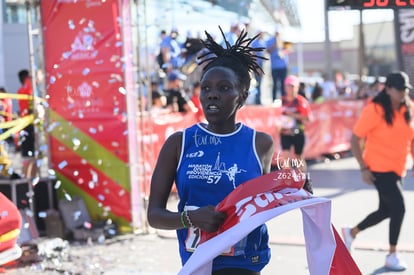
[175, 124, 270, 271]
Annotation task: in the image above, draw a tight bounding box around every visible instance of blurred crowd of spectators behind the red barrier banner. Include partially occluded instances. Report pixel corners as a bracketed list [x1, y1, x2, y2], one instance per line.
[141, 22, 390, 120]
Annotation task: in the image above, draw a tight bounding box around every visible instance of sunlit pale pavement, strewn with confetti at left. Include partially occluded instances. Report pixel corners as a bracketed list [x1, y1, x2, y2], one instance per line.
[0, 152, 414, 275]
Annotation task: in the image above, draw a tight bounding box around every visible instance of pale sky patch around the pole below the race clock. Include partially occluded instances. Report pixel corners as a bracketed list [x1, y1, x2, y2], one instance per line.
[287, 0, 394, 42]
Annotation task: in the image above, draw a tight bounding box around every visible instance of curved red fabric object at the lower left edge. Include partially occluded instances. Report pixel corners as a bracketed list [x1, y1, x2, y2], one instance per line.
[0, 193, 22, 251]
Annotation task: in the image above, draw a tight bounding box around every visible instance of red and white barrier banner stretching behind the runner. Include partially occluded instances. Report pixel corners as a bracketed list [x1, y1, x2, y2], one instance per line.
[138, 100, 365, 196]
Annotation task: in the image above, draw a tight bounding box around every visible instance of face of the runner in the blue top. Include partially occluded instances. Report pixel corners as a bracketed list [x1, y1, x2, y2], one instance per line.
[200, 67, 247, 123]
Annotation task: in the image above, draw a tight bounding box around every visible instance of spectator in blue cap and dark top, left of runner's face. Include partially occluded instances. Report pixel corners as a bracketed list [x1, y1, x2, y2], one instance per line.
[165, 71, 196, 113]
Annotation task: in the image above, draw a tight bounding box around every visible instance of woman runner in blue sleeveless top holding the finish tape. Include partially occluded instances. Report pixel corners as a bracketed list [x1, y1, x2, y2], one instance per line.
[147, 27, 274, 275]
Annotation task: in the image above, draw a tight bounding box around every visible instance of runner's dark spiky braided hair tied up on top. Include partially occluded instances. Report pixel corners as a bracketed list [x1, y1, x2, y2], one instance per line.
[197, 26, 267, 92]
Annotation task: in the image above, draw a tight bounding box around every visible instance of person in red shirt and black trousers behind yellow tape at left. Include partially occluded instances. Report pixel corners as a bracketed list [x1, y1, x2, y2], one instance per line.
[17, 69, 37, 177]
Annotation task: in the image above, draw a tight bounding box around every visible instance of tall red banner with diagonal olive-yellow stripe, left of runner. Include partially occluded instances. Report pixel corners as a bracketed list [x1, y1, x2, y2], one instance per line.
[40, 0, 136, 229]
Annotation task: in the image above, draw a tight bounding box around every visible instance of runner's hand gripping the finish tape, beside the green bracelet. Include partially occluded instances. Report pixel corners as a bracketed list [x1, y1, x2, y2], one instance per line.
[187, 205, 227, 233]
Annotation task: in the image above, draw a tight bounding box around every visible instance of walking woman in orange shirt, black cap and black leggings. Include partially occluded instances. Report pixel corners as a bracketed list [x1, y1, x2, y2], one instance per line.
[342, 72, 414, 271]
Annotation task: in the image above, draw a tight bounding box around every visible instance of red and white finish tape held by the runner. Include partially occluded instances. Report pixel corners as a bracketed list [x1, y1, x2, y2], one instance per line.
[179, 170, 362, 275]
